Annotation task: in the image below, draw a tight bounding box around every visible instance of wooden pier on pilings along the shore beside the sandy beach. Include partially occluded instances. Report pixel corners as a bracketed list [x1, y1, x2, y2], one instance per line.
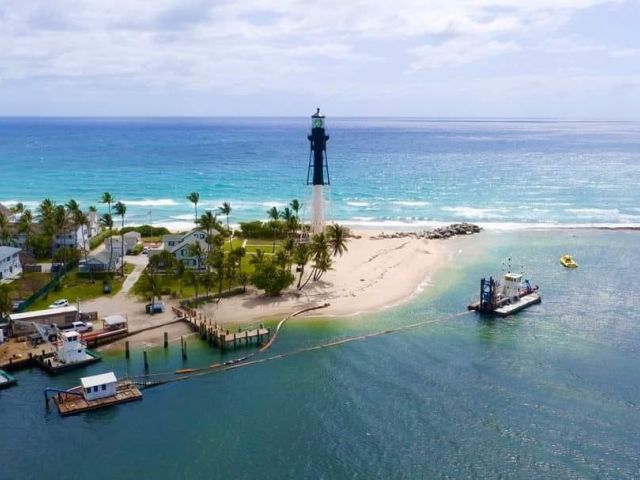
[172, 307, 271, 350]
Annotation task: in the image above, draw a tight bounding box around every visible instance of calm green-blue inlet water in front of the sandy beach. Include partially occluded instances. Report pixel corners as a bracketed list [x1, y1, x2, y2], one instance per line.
[0, 230, 640, 479]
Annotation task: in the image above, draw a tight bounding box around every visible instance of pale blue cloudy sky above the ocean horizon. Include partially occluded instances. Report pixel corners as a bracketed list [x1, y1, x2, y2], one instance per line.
[0, 0, 640, 120]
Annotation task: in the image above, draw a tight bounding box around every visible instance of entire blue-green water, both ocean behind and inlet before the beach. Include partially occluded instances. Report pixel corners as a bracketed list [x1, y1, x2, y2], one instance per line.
[0, 118, 640, 480]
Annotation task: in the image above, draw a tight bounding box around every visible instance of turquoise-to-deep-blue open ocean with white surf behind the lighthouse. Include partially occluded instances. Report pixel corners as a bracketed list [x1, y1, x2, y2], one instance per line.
[0, 117, 640, 228]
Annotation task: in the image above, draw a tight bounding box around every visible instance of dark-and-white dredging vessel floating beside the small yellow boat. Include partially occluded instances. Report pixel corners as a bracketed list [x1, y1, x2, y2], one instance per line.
[467, 272, 542, 317]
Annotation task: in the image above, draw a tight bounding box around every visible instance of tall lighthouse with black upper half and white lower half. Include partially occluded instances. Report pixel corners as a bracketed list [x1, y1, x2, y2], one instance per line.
[307, 108, 331, 234]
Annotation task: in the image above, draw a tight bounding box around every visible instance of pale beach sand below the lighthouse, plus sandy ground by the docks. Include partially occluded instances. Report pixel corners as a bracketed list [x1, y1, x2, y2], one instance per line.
[87, 231, 477, 348]
